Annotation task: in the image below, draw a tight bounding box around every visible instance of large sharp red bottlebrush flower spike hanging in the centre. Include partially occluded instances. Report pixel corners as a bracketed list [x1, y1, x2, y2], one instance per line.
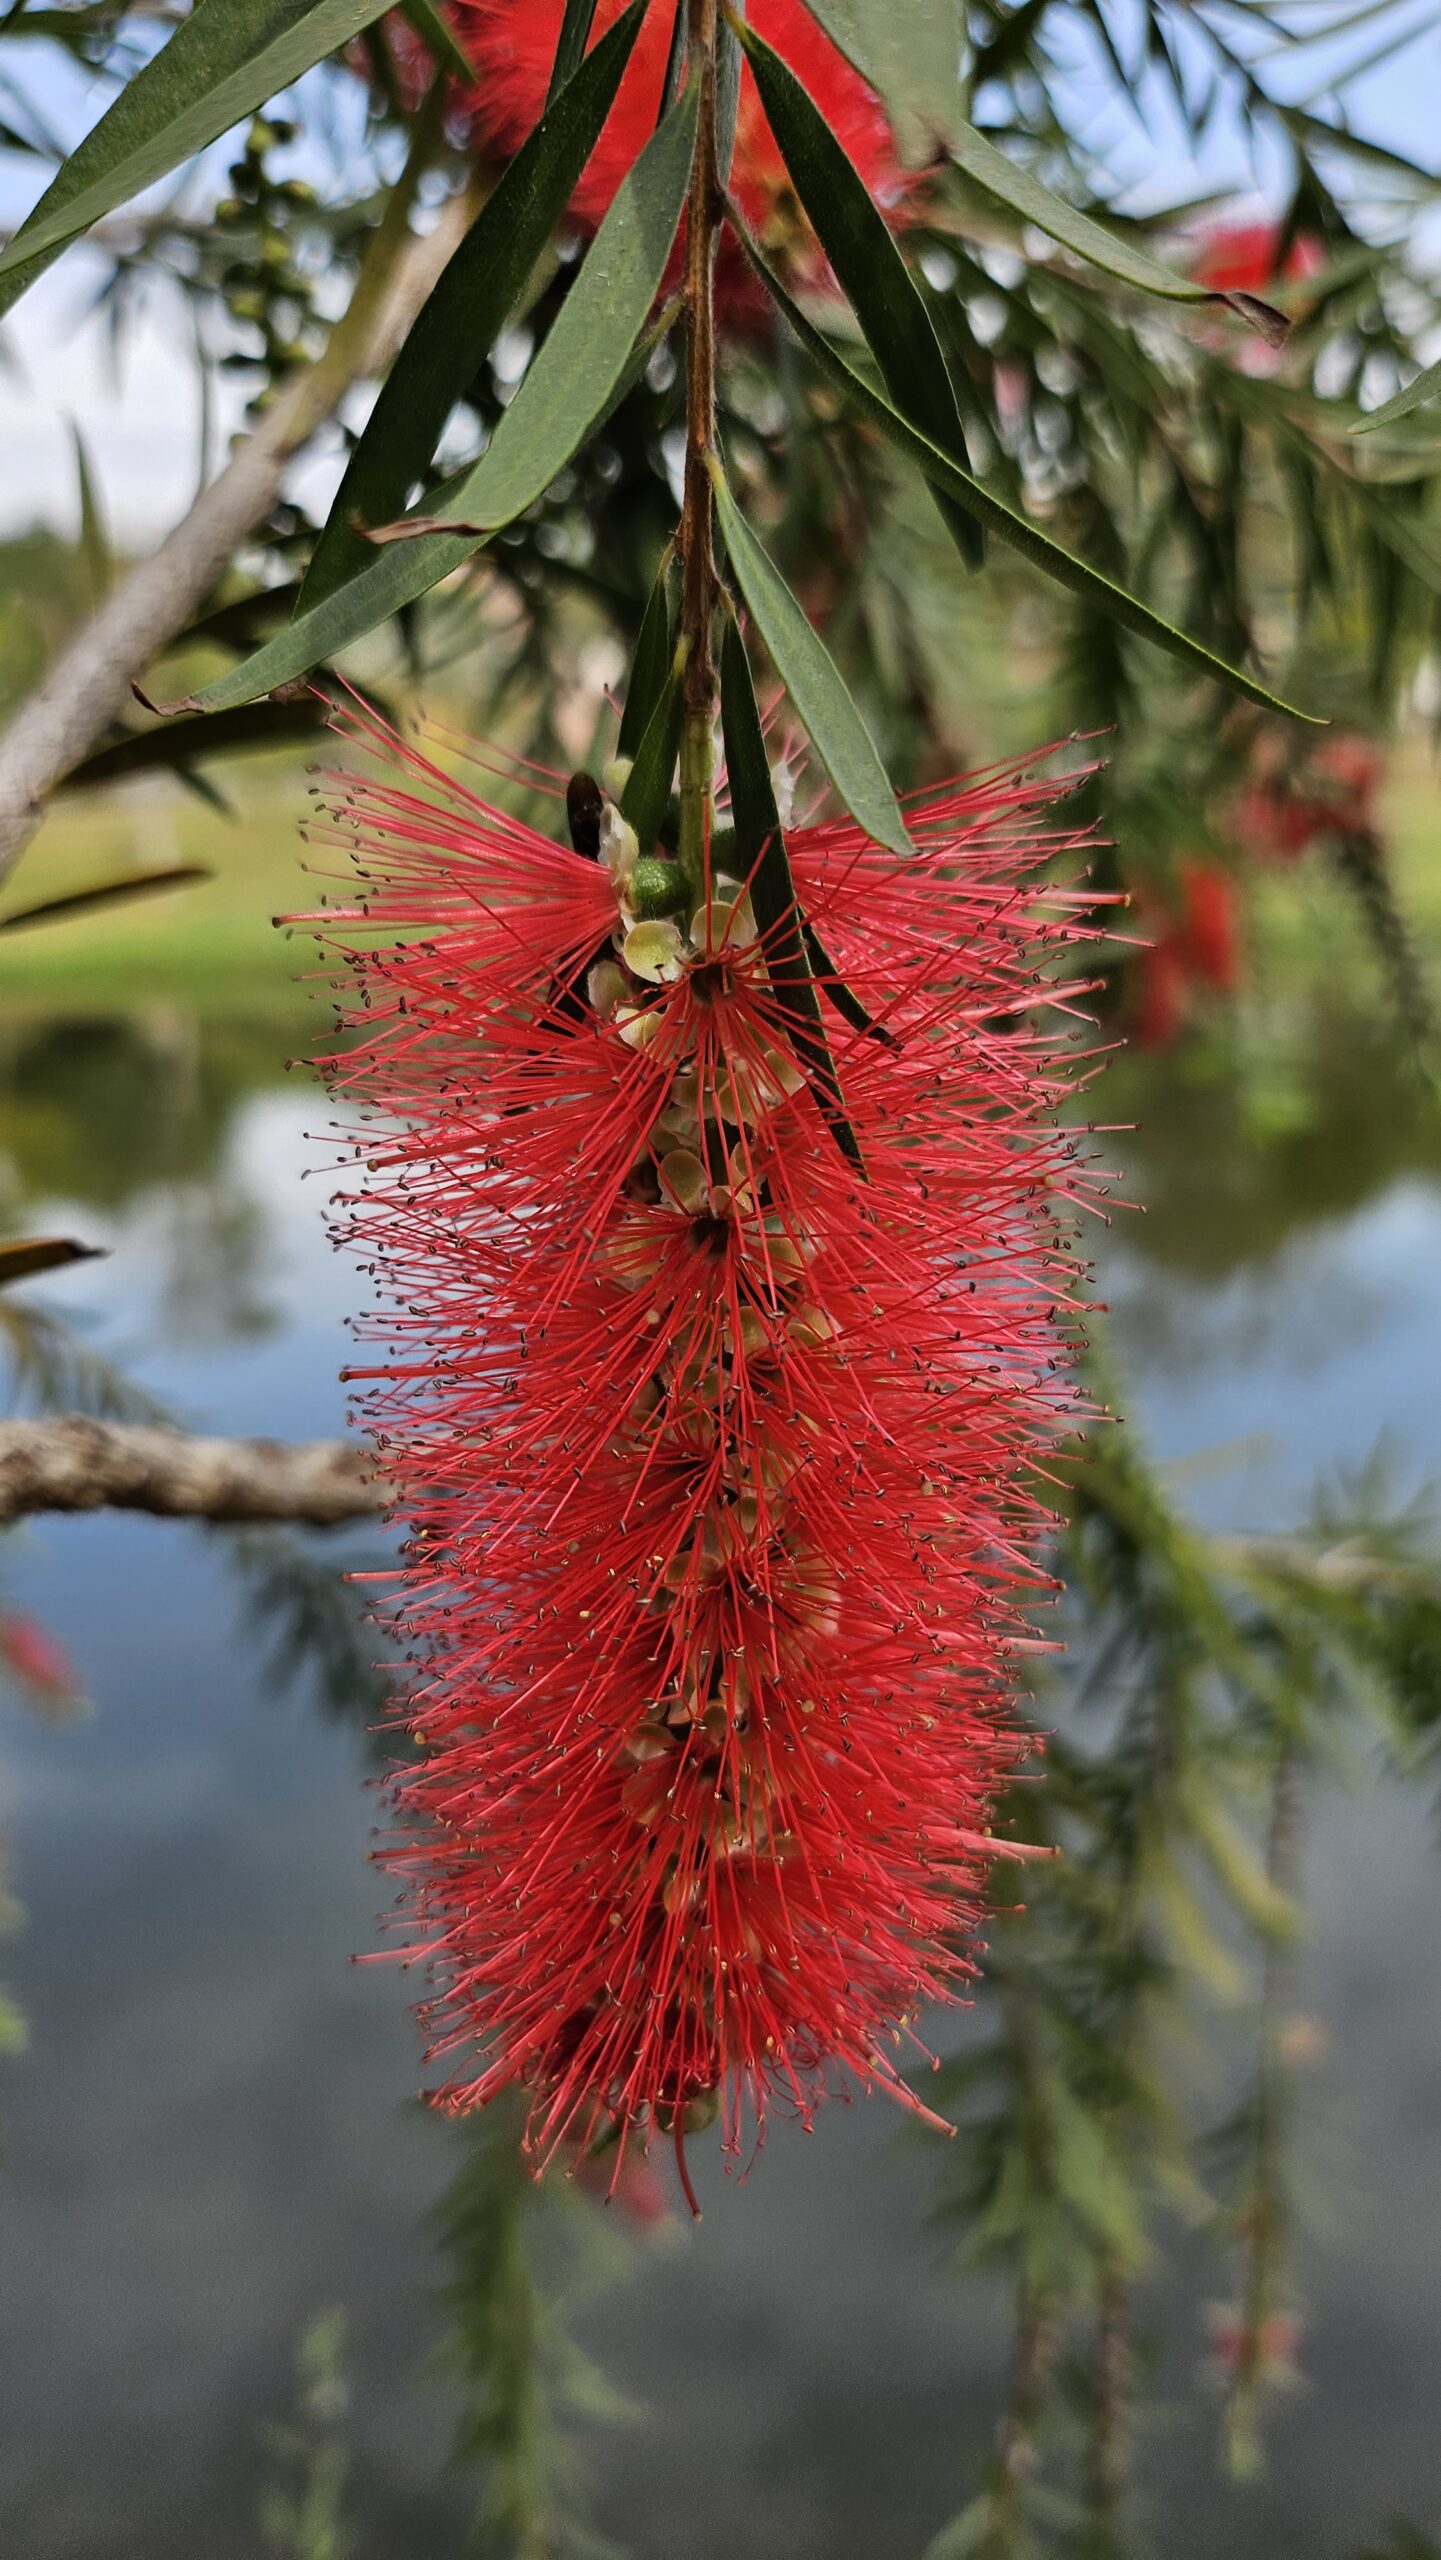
[310, 714, 1090, 2161]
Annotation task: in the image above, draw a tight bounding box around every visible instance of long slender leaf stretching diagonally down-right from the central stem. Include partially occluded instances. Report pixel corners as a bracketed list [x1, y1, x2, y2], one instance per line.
[742, 233, 1323, 727]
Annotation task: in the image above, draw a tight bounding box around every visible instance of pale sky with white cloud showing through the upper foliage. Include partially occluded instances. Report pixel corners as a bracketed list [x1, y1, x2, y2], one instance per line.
[0, 0, 1441, 543]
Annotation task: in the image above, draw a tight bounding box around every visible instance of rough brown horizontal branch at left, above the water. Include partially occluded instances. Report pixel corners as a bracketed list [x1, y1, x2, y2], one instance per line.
[0, 1413, 389, 1528]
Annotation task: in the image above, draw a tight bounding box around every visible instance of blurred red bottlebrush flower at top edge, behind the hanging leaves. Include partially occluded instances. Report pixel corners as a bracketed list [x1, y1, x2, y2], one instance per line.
[424, 0, 911, 325]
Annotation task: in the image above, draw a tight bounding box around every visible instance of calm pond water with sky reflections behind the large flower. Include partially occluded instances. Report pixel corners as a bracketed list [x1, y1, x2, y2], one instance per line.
[0, 1009, 1441, 2560]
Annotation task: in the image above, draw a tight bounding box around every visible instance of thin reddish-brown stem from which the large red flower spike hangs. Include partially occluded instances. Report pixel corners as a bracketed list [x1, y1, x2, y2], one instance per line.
[678, 0, 722, 893]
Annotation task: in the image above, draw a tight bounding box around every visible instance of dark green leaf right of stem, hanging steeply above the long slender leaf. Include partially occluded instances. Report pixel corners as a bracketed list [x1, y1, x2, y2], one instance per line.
[742, 16, 985, 568]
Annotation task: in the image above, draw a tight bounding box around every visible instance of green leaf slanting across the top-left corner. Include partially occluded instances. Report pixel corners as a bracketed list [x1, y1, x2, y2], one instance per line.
[0, 0, 384, 312]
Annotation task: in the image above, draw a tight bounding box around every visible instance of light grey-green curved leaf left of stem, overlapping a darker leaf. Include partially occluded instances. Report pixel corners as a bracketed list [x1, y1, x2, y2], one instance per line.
[187, 84, 699, 712]
